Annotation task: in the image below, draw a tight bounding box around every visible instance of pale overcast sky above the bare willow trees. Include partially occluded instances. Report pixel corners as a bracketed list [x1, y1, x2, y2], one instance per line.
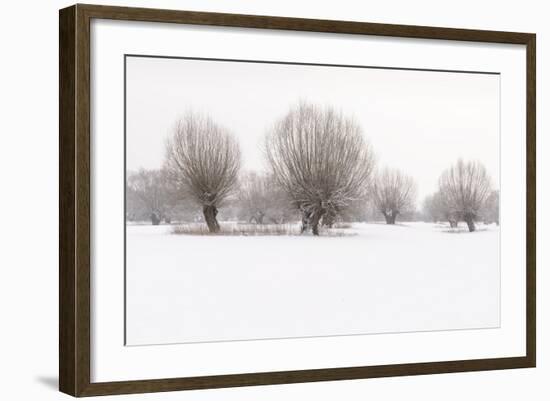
[126, 57, 500, 204]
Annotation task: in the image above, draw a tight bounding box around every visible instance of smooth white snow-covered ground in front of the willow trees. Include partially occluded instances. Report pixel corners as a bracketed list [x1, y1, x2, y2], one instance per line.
[126, 223, 500, 345]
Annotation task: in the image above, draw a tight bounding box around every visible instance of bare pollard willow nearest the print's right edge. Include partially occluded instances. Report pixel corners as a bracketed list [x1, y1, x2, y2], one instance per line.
[439, 159, 491, 232]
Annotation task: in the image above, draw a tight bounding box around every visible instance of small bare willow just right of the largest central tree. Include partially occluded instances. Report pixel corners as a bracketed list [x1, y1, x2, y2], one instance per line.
[373, 168, 416, 224]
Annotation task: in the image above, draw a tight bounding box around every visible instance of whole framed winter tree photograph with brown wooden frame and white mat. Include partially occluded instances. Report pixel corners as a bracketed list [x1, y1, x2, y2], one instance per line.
[59, 5, 536, 396]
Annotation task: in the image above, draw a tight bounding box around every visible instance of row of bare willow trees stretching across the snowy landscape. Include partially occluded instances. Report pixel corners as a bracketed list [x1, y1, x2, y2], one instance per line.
[127, 103, 498, 235]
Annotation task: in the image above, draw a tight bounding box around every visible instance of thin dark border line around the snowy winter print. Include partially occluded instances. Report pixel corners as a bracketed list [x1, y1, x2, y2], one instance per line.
[123, 53, 502, 347]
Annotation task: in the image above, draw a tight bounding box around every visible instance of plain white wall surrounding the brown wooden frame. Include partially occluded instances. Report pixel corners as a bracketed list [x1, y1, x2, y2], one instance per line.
[0, 0, 550, 401]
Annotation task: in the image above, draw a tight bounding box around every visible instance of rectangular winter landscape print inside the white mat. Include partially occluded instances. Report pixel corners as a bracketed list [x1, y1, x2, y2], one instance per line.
[124, 55, 501, 346]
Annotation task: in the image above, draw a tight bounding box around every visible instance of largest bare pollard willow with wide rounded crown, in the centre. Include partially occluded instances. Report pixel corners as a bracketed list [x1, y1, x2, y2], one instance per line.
[265, 103, 374, 235]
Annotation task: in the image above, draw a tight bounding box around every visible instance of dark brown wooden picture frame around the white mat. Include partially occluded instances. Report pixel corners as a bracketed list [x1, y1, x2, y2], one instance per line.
[59, 4, 536, 396]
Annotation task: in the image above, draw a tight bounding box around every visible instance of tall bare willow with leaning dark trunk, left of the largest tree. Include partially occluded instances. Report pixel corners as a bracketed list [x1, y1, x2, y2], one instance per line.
[165, 113, 241, 233]
